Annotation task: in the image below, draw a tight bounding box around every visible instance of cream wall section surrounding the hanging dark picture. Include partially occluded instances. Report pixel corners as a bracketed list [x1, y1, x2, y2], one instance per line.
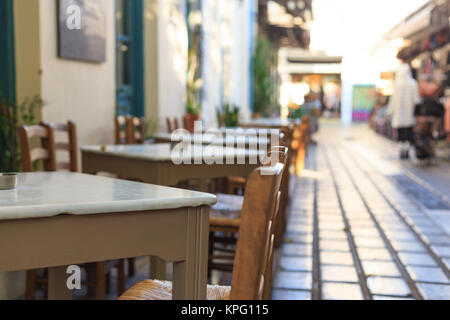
[40, 0, 116, 147]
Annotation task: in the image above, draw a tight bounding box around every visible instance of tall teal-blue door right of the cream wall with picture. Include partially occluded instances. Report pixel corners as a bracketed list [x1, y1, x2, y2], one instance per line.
[116, 0, 144, 117]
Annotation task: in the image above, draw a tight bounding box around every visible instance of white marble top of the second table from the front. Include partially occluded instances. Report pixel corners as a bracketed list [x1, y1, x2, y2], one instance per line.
[81, 143, 266, 163]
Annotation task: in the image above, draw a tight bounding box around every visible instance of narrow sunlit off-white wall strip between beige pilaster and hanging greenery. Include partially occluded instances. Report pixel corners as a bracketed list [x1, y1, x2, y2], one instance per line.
[157, 0, 188, 131]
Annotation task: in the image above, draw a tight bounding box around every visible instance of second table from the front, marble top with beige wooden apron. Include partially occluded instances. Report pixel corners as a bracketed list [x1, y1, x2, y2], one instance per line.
[81, 143, 267, 186]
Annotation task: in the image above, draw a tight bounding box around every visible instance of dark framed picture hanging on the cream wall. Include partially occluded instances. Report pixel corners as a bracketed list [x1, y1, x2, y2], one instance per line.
[58, 0, 109, 63]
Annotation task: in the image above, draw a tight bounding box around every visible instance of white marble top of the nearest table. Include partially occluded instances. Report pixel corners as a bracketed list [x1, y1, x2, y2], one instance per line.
[0, 172, 216, 220]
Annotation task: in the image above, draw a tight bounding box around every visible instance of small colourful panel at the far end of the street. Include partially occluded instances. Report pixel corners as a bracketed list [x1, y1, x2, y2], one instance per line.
[353, 85, 377, 121]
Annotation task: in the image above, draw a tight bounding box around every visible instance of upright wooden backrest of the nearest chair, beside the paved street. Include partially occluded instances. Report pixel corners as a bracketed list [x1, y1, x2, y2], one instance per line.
[230, 158, 284, 300]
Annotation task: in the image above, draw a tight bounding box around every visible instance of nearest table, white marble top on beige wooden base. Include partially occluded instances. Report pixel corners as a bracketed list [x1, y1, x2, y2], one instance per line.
[0, 173, 216, 299]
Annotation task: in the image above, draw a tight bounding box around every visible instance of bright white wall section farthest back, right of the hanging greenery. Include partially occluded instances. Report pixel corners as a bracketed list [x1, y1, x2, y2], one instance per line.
[202, 0, 255, 126]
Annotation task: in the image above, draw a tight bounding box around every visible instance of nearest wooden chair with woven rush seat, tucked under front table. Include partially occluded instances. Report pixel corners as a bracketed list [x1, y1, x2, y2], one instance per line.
[119, 163, 284, 300]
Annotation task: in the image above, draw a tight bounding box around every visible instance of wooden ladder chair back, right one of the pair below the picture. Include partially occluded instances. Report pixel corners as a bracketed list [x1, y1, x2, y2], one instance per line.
[41, 121, 78, 172]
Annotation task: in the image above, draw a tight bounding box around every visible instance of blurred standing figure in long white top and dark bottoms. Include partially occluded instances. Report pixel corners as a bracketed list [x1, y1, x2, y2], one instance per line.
[388, 62, 420, 159]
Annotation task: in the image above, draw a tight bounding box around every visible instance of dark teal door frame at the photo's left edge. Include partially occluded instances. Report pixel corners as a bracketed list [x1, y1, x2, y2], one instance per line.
[0, 0, 16, 102]
